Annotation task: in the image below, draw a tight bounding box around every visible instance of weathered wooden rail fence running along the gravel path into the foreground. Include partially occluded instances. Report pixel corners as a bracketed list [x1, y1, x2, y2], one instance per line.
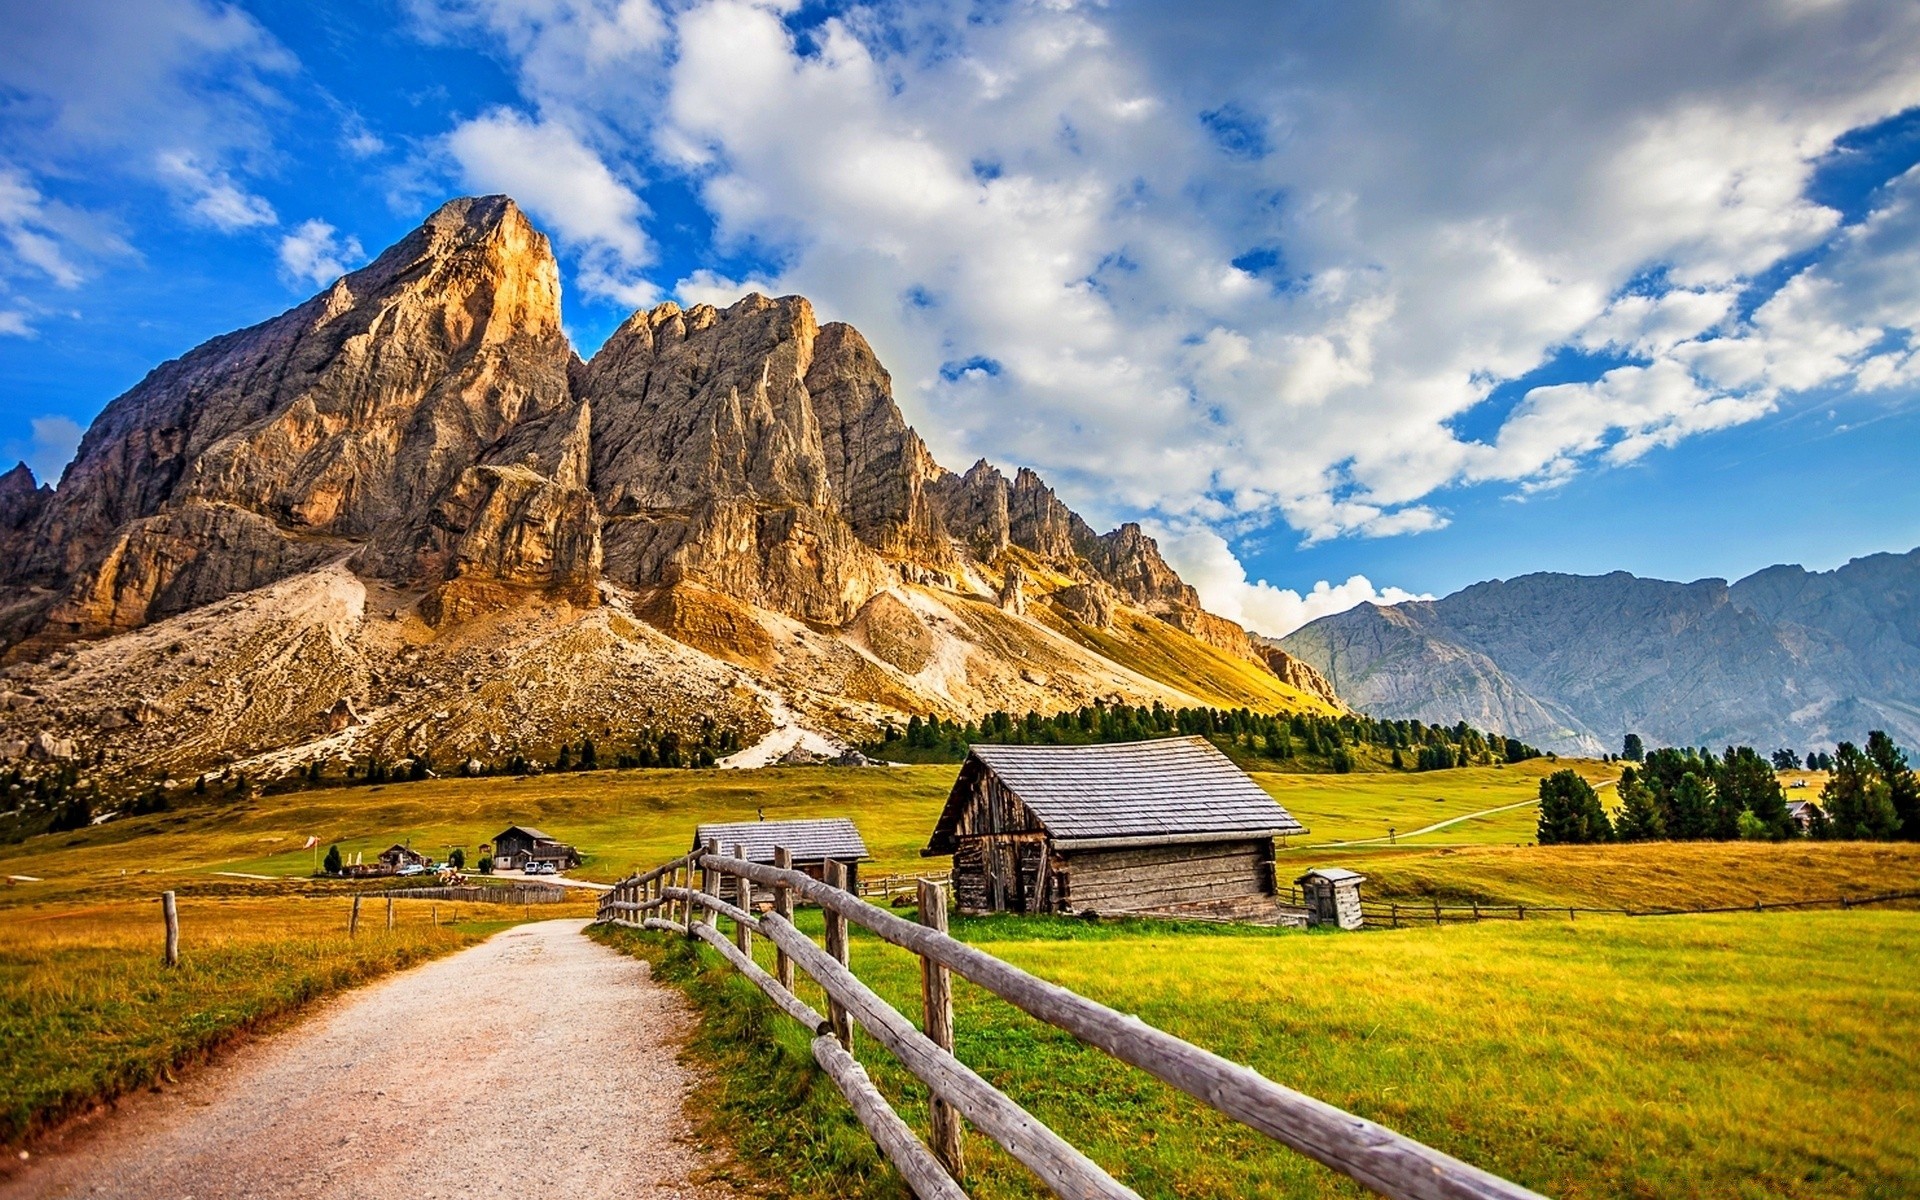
[597, 843, 1538, 1200]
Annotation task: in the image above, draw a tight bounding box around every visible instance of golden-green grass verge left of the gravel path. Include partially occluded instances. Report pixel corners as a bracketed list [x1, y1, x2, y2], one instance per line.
[0, 895, 503, 1146]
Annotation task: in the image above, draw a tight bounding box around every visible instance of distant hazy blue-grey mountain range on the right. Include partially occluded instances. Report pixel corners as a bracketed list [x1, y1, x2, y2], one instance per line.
[1281, 549, 1920, 755]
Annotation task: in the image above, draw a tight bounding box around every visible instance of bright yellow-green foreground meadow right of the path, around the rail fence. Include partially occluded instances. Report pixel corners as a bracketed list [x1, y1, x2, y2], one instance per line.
[593, 910, 1920, 1198]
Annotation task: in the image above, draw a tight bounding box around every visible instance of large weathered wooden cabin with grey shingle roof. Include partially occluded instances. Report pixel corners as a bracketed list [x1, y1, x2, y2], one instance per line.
[922, 737, 1306, 914]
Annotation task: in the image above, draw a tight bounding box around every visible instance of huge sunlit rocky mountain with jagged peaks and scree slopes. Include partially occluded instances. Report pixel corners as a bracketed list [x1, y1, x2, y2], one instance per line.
[0, 196, 1338, 774]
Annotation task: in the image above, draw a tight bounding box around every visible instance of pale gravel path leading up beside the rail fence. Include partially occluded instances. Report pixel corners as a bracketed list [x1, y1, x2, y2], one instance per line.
[0, 920, 732, 1200]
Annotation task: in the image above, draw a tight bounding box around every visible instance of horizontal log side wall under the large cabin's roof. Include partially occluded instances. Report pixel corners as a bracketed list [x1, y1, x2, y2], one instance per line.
[1058, 839, 1273, 912]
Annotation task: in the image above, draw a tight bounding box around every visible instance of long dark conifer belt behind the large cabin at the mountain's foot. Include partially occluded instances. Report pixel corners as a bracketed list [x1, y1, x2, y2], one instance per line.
[860, 701, 1540, 772]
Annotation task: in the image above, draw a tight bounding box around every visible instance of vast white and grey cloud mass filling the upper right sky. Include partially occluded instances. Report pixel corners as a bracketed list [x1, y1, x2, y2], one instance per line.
[415, 0, 1920, 549]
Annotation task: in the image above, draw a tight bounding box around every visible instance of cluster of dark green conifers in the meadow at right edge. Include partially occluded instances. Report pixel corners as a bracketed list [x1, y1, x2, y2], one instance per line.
[1538, 730, 1920, 845]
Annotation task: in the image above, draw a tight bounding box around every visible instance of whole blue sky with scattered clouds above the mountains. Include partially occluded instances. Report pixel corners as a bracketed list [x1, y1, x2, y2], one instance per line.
[0, 0, 1920, 634]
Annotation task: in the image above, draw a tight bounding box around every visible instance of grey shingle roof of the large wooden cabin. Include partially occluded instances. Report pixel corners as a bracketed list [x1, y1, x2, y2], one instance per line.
[927, 737, 1306, 854]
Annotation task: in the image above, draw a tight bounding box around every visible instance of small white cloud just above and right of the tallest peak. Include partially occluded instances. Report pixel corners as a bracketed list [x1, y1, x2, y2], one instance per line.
[447, 108, 657, 307]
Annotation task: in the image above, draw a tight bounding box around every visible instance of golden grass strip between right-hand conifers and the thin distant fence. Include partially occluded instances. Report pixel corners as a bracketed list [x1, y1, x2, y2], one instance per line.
[1344, 841, 1920, 906]
